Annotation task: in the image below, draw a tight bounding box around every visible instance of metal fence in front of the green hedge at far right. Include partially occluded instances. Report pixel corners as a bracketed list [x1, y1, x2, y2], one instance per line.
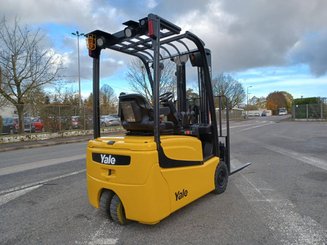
[292, 103, 327, 120]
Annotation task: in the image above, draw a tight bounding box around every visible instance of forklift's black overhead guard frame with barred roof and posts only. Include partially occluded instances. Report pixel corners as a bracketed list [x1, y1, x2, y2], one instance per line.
[86, 14, 219, 159]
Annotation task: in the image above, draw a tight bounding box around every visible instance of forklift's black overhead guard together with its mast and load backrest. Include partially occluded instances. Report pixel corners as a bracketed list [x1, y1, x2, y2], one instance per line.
[87, 14, 230, 171]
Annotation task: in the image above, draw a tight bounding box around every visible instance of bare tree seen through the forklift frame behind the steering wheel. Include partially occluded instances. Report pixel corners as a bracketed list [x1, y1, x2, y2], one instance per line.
[127, 59, 175, 102]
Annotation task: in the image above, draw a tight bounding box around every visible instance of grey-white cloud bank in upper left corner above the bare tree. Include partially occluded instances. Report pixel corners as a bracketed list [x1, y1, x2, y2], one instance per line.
[1, 0, 125, 32]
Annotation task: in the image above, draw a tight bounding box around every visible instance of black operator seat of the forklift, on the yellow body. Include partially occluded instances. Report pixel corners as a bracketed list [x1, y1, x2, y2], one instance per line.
[119, 93, 174, 135]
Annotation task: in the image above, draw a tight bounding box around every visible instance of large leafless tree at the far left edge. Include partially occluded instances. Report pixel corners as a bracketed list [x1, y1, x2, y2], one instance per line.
[0, 18, 61, 133]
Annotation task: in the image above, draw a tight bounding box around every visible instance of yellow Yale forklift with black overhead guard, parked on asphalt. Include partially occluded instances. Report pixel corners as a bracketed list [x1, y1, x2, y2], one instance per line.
[86, 14, 248, 225]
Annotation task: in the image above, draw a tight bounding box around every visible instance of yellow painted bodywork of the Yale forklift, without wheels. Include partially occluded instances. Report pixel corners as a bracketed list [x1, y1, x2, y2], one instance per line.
[86, 135, 219, 224]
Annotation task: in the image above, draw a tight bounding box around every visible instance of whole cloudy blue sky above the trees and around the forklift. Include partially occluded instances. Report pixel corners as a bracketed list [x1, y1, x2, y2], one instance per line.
[0, 0, 327, 98]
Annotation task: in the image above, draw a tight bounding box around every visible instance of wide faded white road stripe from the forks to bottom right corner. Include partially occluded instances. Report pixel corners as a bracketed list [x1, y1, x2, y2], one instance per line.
[233, 174, 327, 245]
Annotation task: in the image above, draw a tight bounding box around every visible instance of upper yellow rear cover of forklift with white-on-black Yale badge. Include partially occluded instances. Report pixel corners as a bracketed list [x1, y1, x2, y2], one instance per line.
[87, 136, 158, 185]
